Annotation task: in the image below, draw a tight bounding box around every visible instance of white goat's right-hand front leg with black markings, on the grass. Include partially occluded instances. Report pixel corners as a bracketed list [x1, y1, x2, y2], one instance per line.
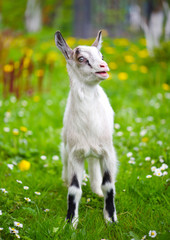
[101, 149, 117, 223]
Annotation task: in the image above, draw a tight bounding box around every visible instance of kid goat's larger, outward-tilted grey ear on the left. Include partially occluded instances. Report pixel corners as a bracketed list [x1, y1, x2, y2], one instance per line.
[55, 31, 73, 60]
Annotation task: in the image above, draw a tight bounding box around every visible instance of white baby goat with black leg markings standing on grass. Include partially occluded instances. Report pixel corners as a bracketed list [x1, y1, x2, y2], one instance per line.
[55, 31, 117, 227]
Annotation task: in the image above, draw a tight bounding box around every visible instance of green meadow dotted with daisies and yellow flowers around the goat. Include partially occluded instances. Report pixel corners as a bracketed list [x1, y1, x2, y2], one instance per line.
[0, 32, 170, 240]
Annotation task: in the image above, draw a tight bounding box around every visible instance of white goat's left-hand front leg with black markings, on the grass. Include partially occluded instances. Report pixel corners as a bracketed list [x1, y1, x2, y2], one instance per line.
[66, 151, 84, 228]
